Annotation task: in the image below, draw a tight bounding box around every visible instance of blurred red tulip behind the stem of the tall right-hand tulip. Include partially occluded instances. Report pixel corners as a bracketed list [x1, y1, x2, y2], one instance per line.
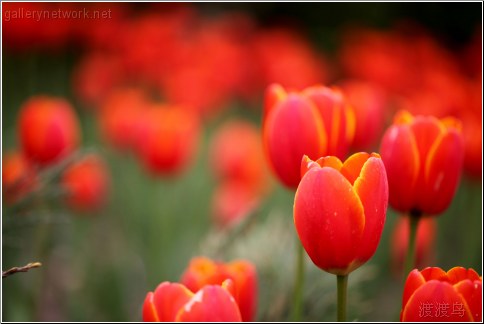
[391, 215, 437, 273]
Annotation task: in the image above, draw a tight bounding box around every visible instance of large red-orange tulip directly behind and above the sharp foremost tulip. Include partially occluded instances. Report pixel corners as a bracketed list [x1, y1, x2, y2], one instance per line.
[263, 84, 355, 188]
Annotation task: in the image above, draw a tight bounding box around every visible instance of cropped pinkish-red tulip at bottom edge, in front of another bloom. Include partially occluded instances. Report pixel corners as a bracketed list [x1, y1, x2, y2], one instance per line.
[143, 280, 241, 322]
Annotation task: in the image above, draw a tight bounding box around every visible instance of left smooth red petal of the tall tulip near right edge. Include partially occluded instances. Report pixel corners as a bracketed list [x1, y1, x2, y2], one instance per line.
[380, 125, 420, 212]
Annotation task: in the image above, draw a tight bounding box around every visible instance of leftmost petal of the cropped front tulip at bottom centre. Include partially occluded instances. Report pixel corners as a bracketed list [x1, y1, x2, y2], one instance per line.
[153, 282, 193, 322]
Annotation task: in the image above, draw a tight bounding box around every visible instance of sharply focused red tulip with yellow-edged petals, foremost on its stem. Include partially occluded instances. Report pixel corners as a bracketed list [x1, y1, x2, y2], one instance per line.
[294, 153, 388, 275]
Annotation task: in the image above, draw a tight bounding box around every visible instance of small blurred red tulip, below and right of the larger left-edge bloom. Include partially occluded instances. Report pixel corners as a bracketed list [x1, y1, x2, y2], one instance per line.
[61, 155, 110, 211]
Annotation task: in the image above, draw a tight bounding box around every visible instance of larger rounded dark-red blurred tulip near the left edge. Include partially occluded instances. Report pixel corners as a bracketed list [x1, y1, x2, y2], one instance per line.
[18, 96, 80, 165]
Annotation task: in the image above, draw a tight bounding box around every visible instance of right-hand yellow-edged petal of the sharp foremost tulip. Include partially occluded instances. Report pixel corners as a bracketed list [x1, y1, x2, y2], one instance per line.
[350, 153, 388, 264]
